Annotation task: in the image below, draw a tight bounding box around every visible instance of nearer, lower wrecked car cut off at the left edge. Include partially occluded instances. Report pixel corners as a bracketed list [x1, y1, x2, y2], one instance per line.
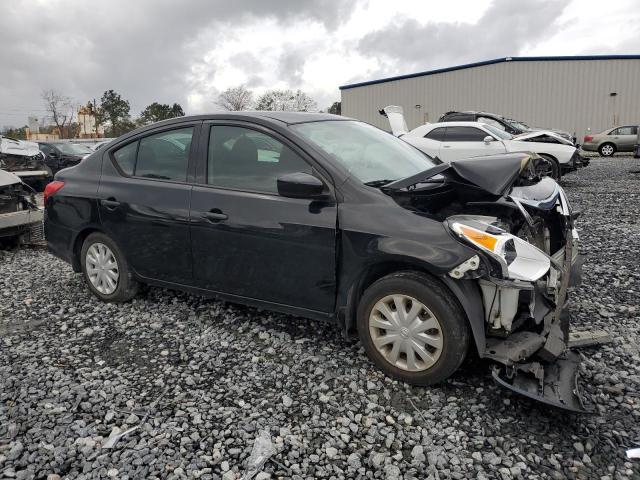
[0, 170, 43, 243]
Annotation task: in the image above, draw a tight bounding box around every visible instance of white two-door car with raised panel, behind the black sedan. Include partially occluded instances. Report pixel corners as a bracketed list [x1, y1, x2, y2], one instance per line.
[383, 106, 585, 179]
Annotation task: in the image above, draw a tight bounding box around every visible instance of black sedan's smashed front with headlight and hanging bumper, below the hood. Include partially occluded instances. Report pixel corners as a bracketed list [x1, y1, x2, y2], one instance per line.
[446, 174, 585, 412]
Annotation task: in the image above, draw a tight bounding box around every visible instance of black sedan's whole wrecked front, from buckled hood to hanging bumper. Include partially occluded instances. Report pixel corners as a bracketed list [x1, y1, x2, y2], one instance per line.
[383, 153, 585, 412]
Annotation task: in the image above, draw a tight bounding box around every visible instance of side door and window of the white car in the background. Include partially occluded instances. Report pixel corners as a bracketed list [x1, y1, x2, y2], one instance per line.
[440, 126, 506, 162]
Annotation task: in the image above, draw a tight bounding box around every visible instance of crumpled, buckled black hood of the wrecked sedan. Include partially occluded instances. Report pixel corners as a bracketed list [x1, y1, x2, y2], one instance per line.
[383, 152, 535, 195]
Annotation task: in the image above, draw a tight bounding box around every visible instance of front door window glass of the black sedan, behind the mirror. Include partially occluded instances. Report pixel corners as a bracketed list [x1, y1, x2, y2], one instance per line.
[207, 125, 312, 194]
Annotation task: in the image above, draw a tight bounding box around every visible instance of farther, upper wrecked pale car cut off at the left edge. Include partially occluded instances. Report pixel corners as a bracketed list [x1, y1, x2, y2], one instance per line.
[0, 135, 53, 191]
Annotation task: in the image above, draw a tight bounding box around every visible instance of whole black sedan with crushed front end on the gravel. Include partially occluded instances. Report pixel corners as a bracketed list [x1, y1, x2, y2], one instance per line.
[45, 111, 582, 411]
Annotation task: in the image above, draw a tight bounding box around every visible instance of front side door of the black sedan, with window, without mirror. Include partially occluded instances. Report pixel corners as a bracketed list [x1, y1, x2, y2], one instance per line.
[191, 122, 337, 313]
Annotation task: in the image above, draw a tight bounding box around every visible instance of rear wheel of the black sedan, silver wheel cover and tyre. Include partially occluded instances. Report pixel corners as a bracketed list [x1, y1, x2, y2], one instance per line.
[80, 232, 138, 302]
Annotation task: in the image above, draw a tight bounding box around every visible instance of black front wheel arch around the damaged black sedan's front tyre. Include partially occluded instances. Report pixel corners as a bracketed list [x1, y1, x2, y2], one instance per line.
[339, 260, 486, 356]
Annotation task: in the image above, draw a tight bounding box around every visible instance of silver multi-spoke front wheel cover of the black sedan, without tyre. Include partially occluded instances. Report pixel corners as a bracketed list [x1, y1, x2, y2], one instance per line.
[369, 294, 444, 372]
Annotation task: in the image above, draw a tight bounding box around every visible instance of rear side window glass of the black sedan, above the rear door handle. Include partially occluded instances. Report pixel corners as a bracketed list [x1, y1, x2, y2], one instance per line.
[113, 127, 193, 182]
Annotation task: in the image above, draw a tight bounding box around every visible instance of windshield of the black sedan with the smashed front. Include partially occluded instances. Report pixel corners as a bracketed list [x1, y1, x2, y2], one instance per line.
[291, 120, 437, 184]
